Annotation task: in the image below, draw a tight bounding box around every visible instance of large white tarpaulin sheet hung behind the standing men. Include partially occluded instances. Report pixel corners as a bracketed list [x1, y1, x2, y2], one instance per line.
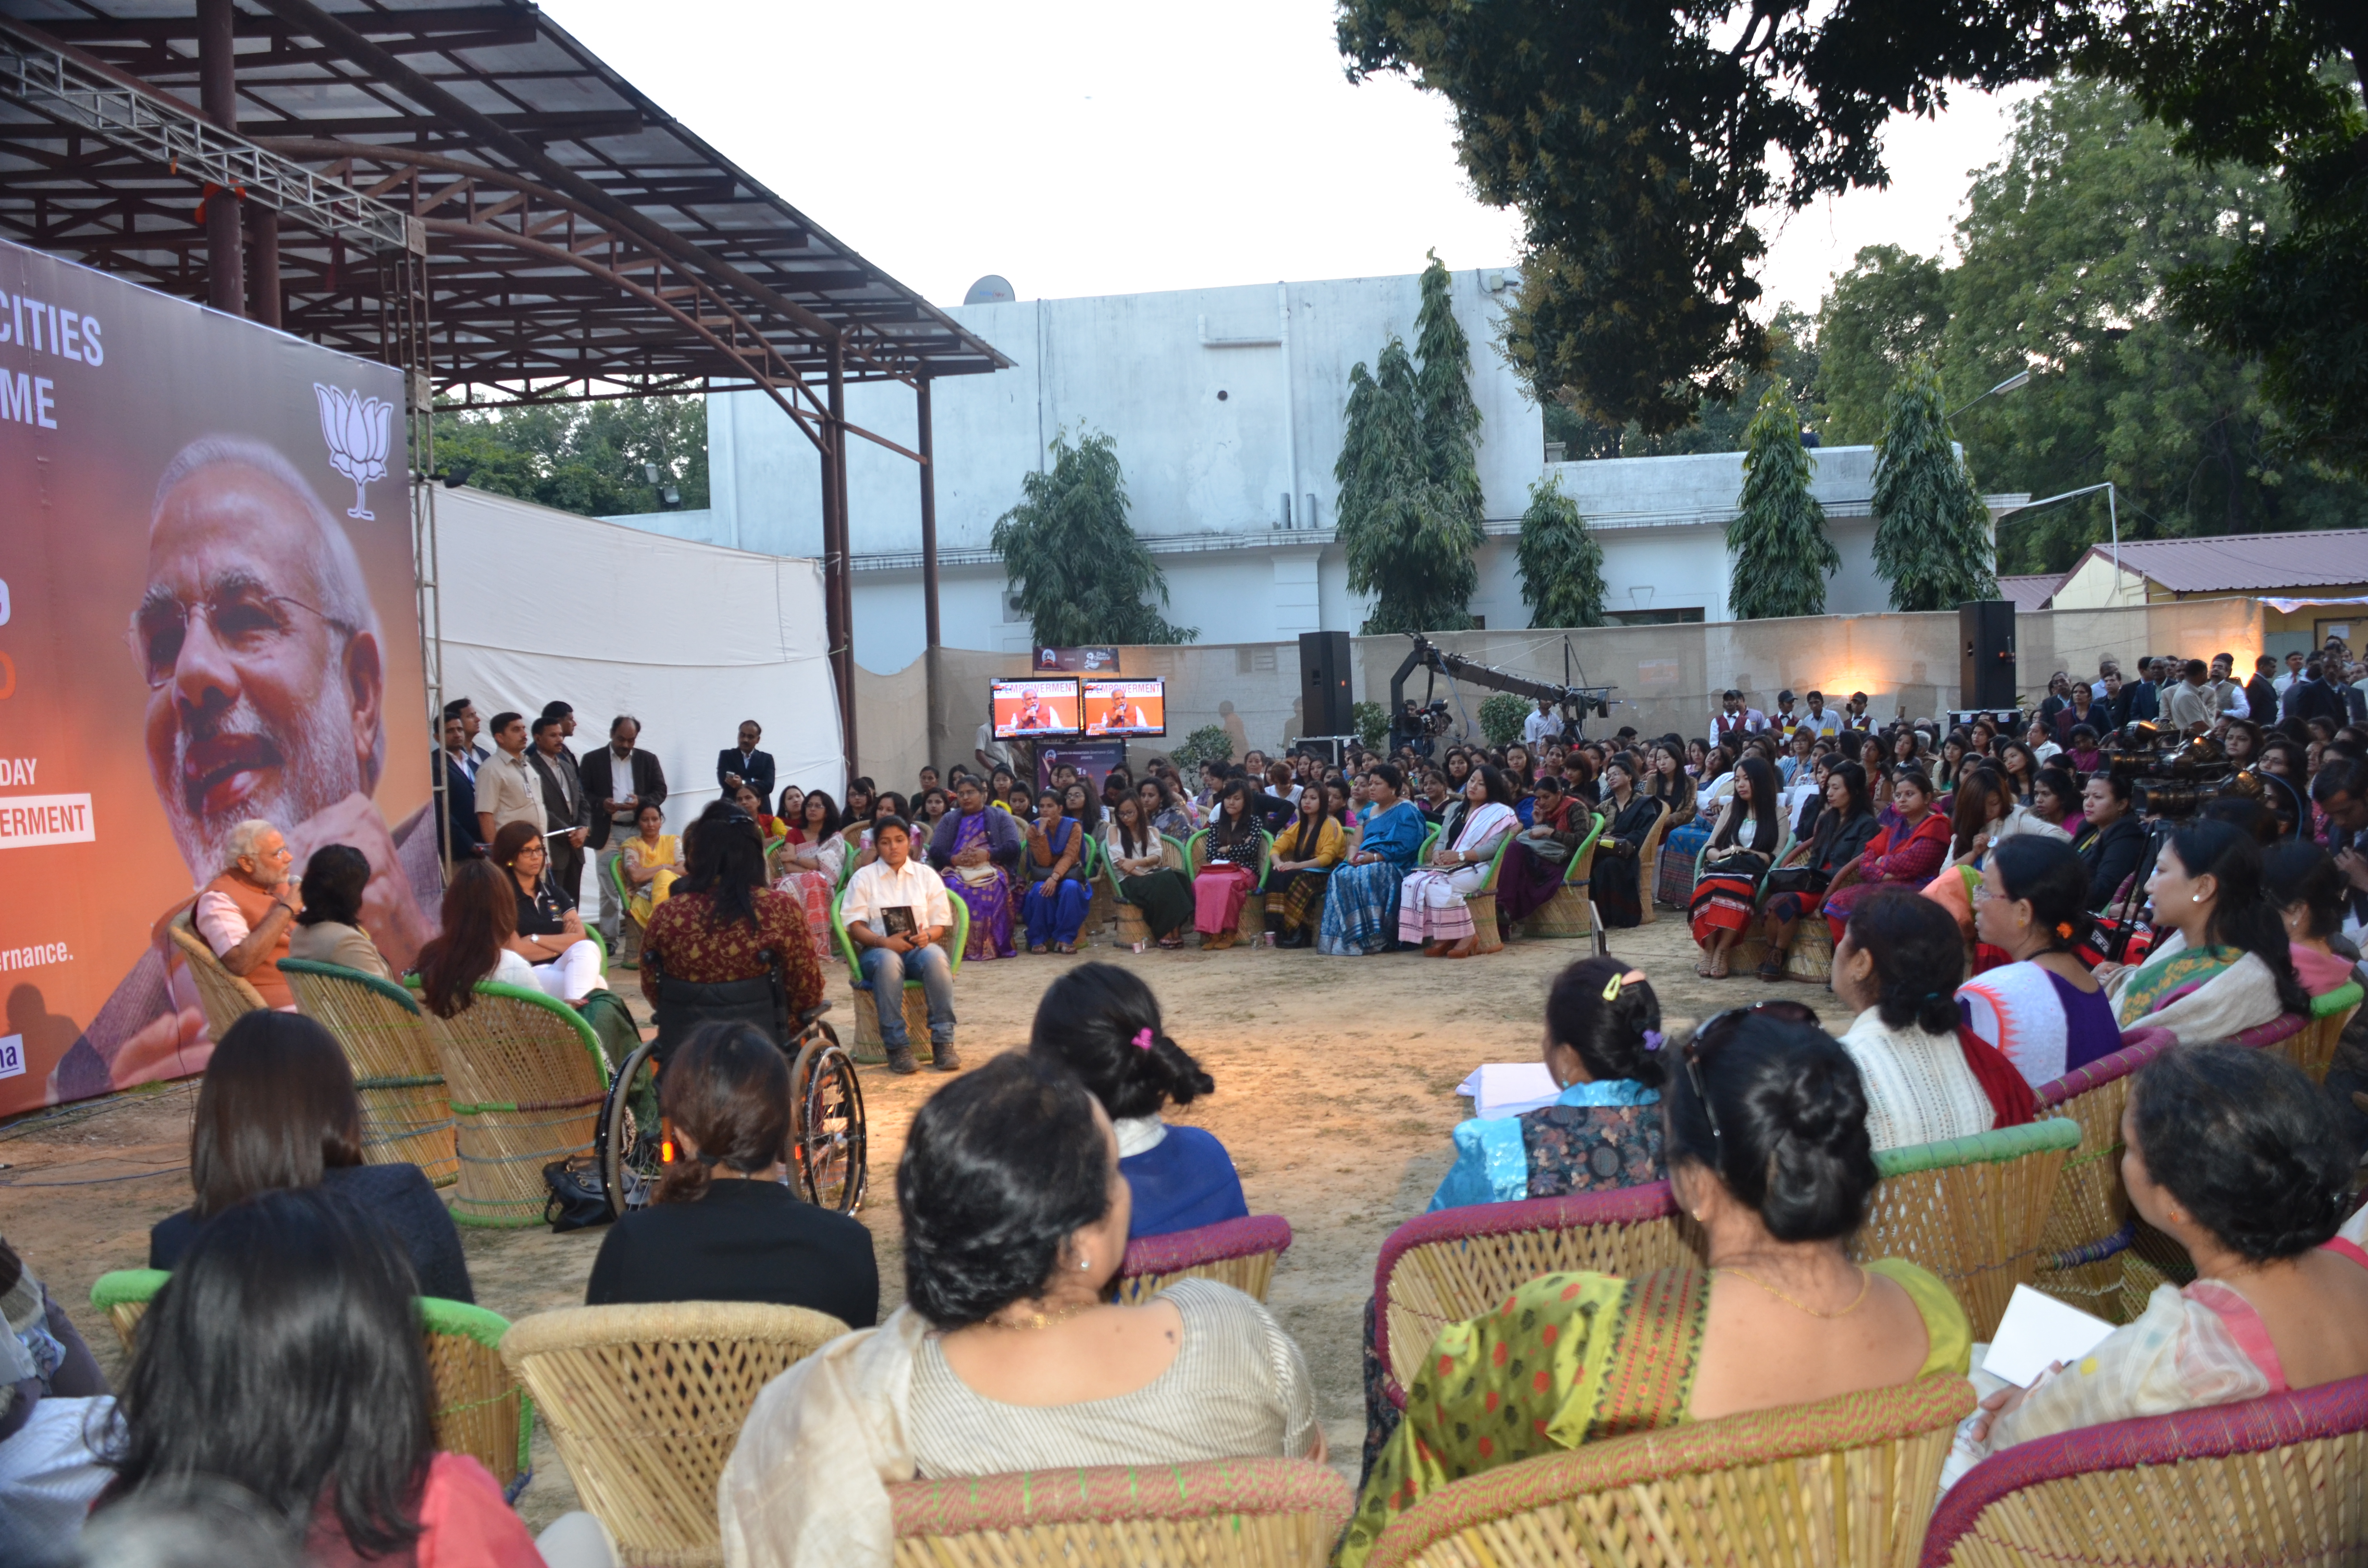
[436, 488, 845, 886]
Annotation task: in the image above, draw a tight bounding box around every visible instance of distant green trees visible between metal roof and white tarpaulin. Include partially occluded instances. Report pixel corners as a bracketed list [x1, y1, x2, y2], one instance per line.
[436, 398, 708, 516]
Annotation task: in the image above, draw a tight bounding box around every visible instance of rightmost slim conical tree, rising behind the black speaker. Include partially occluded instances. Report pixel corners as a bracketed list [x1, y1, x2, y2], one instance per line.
[1875, 358, 1998, 609]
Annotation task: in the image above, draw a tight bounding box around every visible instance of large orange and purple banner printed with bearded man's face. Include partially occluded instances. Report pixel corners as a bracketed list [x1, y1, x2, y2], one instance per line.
[0, 244, 441, 1113]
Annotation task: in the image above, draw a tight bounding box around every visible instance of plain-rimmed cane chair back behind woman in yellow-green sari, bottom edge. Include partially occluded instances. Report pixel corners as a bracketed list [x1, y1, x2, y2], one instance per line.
[1366, 1374, 1973, 1568]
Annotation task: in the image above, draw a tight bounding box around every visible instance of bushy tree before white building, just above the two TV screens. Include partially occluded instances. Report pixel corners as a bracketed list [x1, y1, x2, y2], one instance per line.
[990, 431, 1200, 647]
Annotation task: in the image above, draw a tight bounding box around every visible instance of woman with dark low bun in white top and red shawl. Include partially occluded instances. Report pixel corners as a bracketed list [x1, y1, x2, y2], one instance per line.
[1833, 888, 2032, 1149]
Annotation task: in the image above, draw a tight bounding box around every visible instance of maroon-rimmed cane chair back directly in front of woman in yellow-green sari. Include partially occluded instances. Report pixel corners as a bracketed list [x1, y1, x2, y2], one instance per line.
[1373, 1182, 1700, 1407]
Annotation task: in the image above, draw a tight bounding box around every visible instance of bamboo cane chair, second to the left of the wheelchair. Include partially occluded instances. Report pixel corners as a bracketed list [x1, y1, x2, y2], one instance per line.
[280, 959, 459, 1187]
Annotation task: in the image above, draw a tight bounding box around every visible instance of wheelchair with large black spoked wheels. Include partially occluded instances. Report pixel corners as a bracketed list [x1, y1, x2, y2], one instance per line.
[597, 957, 867, 1220]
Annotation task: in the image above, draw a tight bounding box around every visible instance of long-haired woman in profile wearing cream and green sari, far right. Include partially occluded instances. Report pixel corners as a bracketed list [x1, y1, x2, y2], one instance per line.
[2096, 817, 2311, 1044]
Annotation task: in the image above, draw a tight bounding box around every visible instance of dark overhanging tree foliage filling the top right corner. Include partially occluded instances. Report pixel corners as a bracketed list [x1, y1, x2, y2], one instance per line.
[1338, 0, 2368, 466]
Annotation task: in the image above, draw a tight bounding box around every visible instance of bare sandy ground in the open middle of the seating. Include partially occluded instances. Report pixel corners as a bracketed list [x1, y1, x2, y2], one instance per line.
[0, 909, 1809, 1528]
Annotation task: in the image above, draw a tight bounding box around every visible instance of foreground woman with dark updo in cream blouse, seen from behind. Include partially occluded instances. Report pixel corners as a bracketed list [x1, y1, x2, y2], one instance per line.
[717, 1054, 1324, 1568]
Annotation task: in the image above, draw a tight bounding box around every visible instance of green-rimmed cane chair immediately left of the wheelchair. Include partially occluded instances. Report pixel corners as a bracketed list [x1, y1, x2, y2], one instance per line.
[429, 980, 608, 1229]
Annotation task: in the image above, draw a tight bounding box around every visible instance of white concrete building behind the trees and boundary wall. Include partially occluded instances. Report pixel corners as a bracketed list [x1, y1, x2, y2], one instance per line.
[613, 270, 2023, 670]
